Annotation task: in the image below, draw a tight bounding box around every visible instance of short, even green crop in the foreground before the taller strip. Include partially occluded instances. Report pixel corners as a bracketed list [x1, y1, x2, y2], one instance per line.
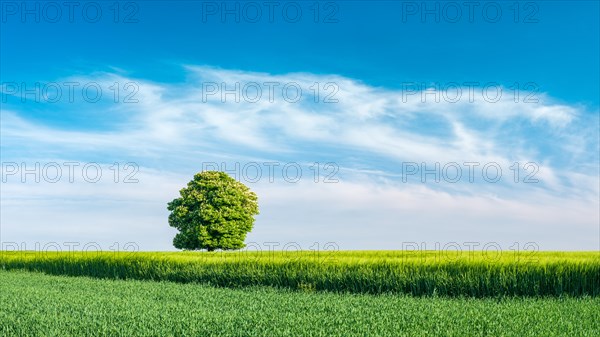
[0, 271, 600, 337]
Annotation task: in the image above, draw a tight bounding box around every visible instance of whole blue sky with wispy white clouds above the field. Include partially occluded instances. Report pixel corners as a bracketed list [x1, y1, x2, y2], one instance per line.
[0, 1, 600, 250]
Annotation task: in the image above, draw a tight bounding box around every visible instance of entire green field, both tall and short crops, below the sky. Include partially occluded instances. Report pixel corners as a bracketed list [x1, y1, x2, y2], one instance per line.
[0, 251, 600, 336]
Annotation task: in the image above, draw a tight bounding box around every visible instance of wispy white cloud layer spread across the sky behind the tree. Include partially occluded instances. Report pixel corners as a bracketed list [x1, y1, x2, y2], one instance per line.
[0, 66, 599, 249]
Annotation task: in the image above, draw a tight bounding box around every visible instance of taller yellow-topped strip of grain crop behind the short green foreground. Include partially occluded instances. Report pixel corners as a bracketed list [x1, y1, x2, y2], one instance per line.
[0, 251, 600, 297]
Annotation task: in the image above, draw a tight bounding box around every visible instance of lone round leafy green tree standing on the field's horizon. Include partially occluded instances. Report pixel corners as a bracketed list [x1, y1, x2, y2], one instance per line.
[167, 171, 258, 251]
